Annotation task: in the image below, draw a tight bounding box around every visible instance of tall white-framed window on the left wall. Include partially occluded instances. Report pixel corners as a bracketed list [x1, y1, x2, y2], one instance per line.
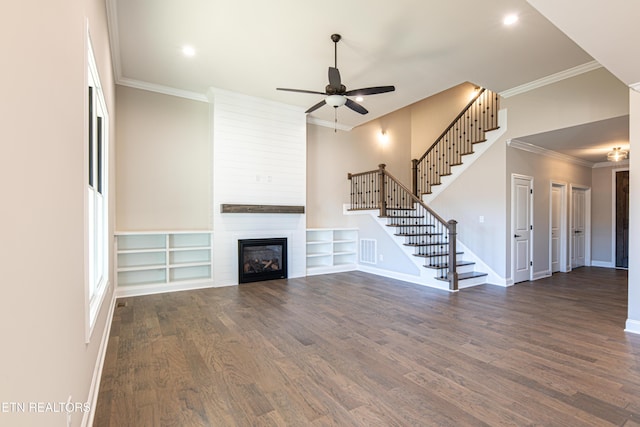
[85, 34, 109, 342]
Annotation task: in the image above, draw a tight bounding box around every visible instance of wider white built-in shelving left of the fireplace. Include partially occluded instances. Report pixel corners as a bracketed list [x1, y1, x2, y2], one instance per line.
[115, 231, 213, 296]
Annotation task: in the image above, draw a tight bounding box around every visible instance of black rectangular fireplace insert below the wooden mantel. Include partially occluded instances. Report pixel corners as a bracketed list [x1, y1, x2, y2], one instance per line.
[238, 238, 287, 283]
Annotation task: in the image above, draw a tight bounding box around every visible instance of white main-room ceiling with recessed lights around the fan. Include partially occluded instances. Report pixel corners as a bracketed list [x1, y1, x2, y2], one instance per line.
[108, 0, 593, 127]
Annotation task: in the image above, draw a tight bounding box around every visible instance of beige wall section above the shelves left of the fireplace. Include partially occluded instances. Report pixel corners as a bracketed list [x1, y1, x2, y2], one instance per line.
[116, 86, 213, 231]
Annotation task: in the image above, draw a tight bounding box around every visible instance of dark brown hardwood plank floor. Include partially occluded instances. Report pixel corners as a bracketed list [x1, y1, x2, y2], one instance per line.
[94, 267, 640, 427]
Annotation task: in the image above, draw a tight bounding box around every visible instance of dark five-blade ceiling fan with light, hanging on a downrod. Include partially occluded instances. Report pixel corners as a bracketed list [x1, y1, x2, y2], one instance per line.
[276, 34, 396, 114]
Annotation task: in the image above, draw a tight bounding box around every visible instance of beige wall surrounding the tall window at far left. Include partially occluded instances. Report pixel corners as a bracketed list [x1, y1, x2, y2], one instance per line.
[0, 0, 115, 426]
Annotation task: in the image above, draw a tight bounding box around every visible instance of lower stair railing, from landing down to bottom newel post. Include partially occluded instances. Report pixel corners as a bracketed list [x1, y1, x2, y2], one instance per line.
[347, 164, 458, 290]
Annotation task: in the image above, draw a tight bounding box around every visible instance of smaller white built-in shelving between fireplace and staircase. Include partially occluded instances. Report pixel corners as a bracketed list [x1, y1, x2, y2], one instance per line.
[307, 228, 358, 276]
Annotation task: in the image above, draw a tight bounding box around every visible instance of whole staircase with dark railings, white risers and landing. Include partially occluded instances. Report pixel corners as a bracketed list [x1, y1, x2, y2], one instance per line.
[348, 89, 498, 291]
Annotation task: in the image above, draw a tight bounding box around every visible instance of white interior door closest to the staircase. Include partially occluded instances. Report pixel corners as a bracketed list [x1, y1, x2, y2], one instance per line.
[511, 176, 533, 283]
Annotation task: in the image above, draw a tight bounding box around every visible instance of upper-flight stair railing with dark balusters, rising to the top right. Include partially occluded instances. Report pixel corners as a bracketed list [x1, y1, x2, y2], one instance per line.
[411, 88, 499, 197]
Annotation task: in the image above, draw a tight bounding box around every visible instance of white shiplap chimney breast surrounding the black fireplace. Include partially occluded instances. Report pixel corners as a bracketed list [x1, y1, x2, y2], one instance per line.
[209, 90, 307, 286]
